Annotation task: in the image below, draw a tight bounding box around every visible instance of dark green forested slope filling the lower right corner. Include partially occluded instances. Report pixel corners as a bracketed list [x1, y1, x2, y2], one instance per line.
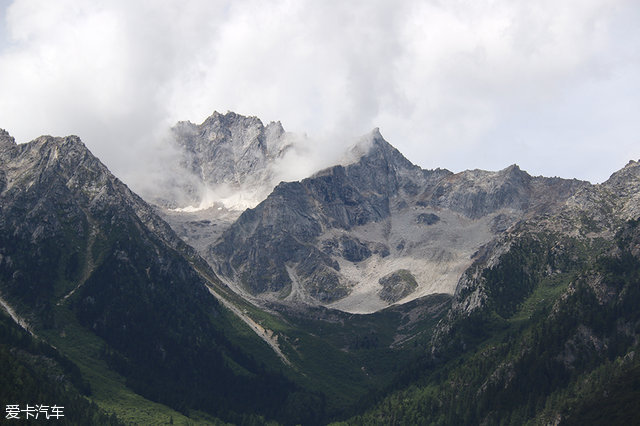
[340, 221, 640, 425]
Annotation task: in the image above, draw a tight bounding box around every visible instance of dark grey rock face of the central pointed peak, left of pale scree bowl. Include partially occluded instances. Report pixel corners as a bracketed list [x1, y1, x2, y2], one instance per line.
[209, 133, 427, 302]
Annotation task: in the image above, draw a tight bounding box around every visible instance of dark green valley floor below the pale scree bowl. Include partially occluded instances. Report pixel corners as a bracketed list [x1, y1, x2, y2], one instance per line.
[201, 271, 450, 418]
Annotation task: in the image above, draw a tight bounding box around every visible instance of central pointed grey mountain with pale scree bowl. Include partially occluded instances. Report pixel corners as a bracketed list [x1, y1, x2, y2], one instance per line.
[204, 129, 588, 313]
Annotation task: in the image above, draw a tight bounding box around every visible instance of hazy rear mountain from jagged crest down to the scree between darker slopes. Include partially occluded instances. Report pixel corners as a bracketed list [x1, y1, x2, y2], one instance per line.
[151, 112, 299, 262]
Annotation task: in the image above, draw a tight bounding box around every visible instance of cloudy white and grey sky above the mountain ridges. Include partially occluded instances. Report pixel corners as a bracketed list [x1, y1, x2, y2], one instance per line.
[0, 0, 640, 189]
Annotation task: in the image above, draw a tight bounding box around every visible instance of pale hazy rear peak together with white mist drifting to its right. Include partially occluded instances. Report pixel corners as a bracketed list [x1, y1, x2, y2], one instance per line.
[149, 111, 345, 212]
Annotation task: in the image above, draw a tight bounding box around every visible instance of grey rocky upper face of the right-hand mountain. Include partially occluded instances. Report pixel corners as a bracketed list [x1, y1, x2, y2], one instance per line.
[439, 161, 640, 334]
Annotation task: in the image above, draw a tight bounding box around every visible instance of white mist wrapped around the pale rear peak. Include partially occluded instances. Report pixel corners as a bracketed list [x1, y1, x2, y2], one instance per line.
[159, 123, 364, 212]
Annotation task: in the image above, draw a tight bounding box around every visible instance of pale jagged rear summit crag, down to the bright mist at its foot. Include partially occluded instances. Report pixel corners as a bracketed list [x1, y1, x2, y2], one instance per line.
[152, 112, 295, 211]
